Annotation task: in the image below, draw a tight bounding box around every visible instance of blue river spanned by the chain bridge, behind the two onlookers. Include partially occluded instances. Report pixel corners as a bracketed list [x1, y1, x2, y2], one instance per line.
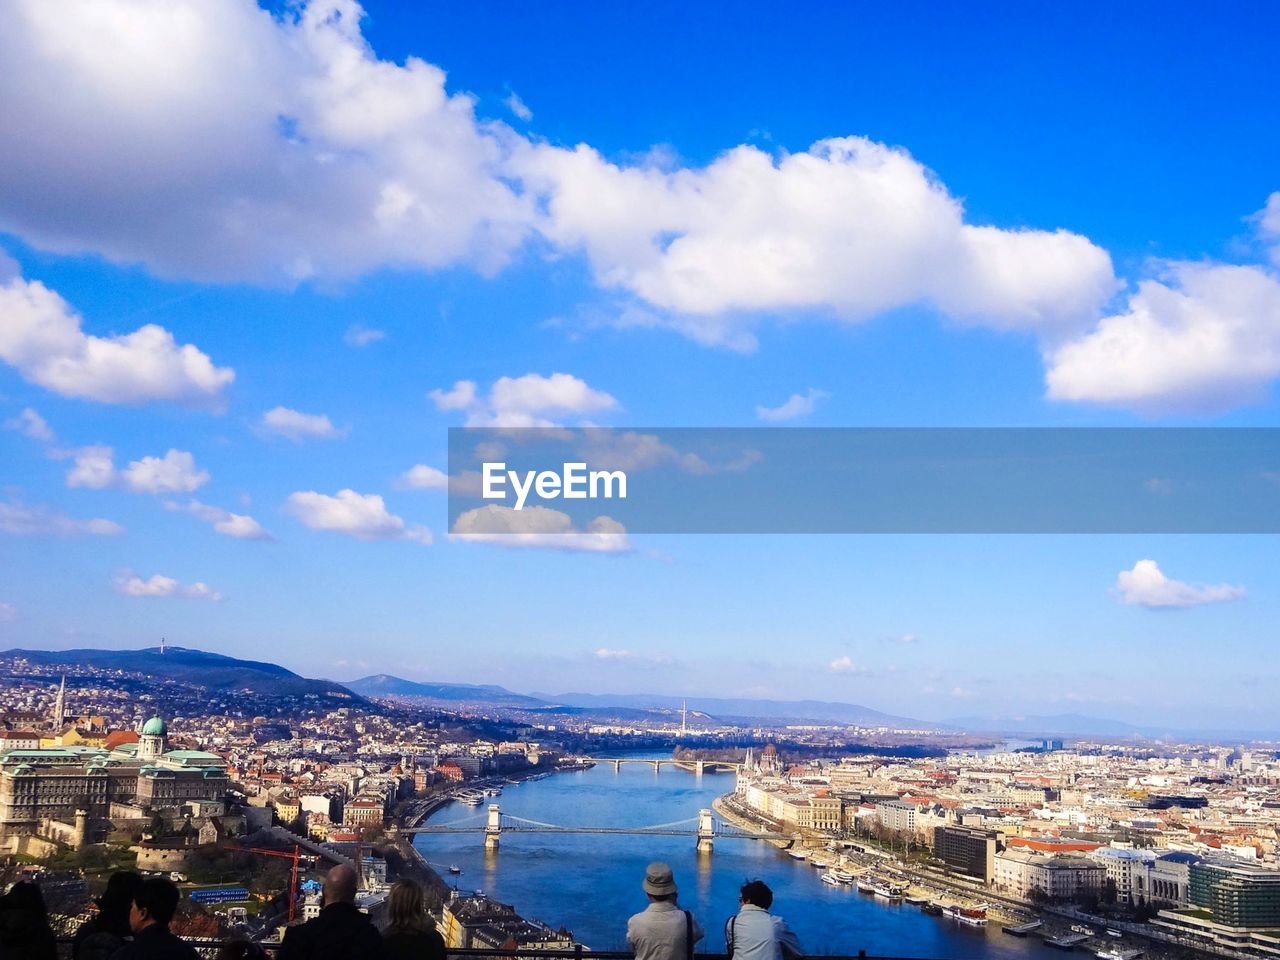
[415, 763, 1062, 960]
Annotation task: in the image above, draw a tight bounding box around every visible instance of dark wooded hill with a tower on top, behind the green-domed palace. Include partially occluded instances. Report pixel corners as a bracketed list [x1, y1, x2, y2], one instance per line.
[0, 646, 361, 700]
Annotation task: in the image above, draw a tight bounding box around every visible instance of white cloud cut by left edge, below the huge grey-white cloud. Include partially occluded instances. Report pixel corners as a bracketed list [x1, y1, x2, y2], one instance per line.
[0, 273, 236, 406]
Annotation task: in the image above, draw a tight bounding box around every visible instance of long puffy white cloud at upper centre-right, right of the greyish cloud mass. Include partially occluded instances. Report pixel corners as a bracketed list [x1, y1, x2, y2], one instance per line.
[513, 137, 1116, 342]
